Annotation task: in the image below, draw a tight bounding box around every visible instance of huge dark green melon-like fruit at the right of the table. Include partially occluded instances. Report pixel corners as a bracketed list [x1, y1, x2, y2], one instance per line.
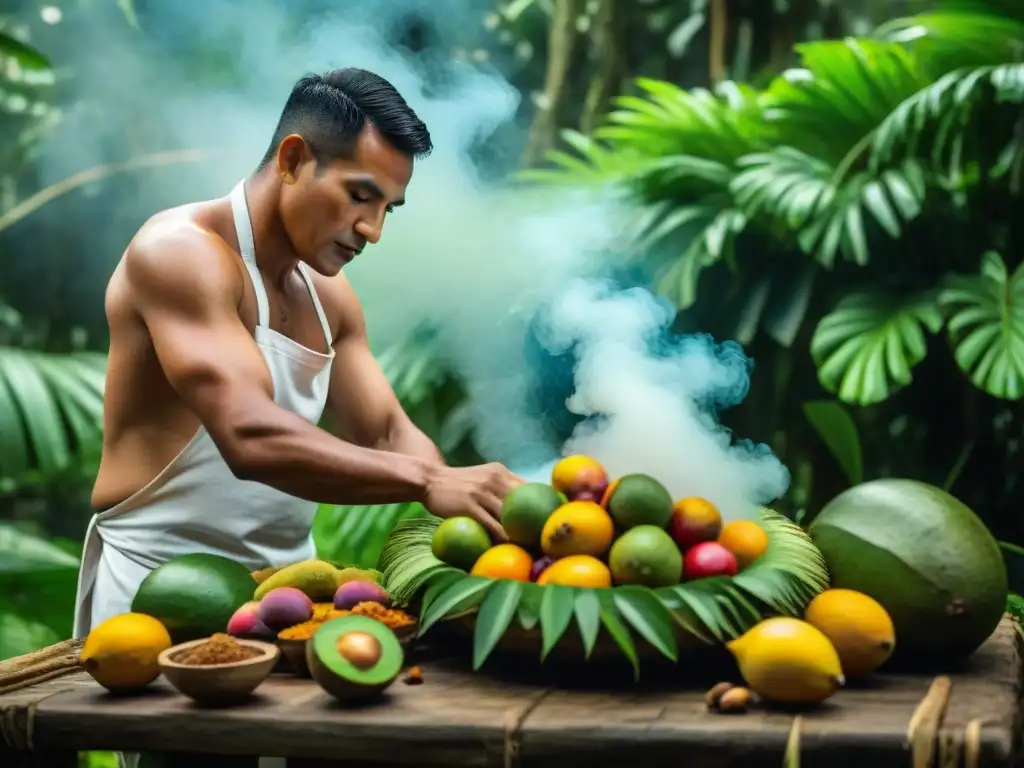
[808, 479, 1008, 660]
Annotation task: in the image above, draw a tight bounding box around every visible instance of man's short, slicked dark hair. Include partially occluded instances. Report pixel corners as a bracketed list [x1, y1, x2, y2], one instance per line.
[259, 67, 433, 168]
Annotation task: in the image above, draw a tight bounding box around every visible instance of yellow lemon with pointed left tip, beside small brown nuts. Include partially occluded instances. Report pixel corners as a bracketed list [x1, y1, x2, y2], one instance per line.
[726, 616, 846, 703]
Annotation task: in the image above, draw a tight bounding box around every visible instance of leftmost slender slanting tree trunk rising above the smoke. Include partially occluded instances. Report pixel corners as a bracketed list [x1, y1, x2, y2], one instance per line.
[522, 0, 584, 167]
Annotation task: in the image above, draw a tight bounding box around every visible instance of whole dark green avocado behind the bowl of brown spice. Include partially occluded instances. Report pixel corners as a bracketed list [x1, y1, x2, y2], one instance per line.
[131, 553, 256, 644]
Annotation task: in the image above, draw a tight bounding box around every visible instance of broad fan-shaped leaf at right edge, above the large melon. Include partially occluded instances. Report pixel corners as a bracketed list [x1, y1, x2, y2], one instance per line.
[939, 253, 1024, 400]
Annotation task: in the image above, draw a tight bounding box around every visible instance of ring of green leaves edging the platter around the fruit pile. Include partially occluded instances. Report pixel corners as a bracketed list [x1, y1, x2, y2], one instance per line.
[378, 509, 828, 678]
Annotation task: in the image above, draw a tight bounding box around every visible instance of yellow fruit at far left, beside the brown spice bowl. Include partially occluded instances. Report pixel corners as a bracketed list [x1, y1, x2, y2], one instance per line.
[80, 613, 171, 691]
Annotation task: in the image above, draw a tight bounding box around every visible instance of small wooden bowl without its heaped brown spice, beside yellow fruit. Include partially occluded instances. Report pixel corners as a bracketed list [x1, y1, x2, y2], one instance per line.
[157, 638, 281, 705]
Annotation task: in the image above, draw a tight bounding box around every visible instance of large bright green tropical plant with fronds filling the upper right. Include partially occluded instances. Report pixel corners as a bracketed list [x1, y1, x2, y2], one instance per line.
[524, 0, 1024, 404]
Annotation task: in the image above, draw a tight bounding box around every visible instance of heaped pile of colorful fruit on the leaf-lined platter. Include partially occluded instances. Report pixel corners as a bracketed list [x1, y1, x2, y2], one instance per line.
[425, 456, 768, 588]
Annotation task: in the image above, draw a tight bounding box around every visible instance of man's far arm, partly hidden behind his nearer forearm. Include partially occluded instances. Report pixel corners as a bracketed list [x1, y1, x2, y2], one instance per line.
[327, 275, 444, 464]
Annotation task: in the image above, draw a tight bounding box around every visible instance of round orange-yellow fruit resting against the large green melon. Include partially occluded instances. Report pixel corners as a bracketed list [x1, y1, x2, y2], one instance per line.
[804, 589, 896, 678]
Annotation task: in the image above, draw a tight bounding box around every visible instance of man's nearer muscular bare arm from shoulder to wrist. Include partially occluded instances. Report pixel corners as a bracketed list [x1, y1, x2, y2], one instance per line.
[125, 227, 436, 504]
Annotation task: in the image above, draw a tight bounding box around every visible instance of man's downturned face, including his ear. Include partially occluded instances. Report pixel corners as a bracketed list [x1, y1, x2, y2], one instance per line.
[281, 125, 413, 276]
